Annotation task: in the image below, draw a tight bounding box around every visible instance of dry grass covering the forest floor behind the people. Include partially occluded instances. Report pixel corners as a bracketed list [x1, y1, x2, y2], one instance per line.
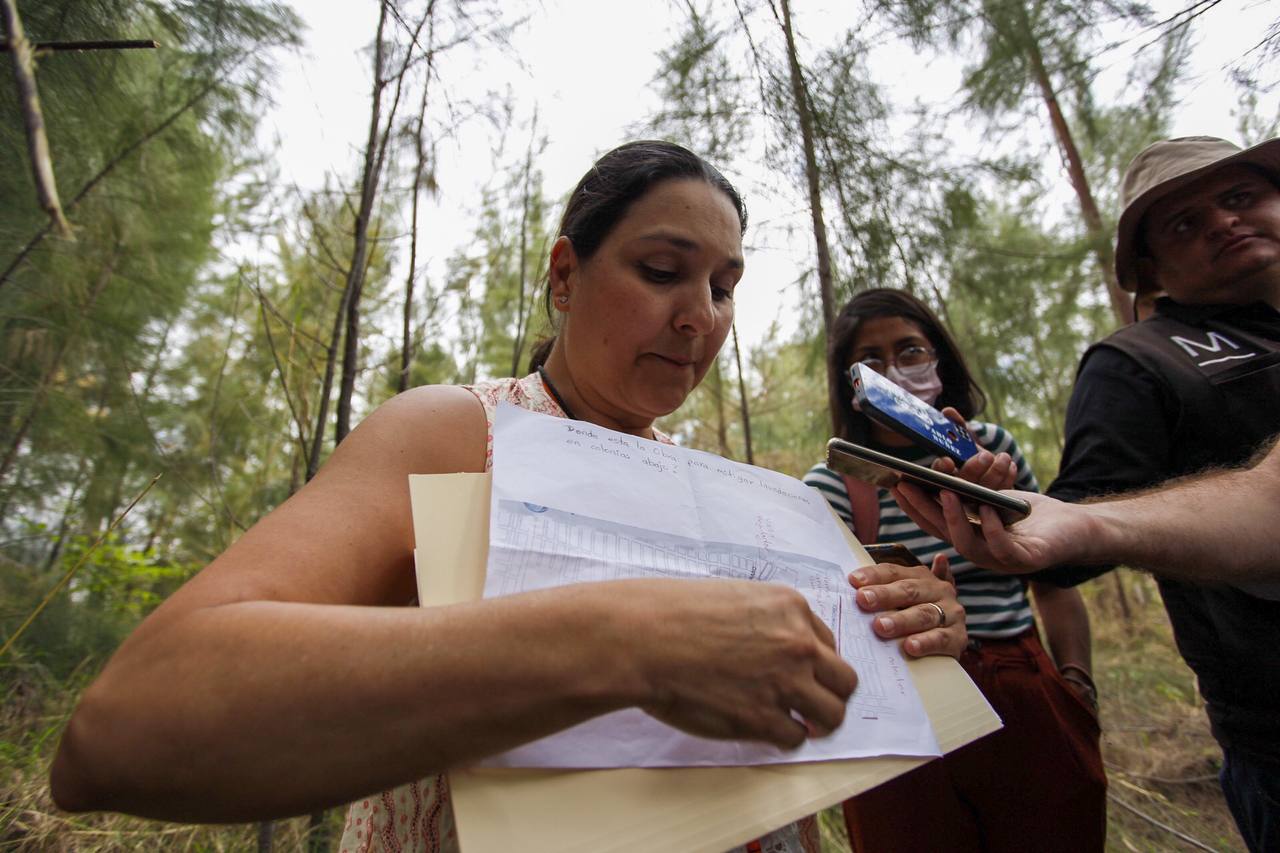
[0, 573, 1244, 853]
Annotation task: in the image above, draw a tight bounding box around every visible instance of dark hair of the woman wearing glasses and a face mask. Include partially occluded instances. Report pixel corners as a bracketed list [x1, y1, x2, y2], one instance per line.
[827, 287, 987, 443]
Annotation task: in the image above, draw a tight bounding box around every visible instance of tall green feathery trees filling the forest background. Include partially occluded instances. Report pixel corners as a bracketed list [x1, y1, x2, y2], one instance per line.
[0, 0, 1259, 849]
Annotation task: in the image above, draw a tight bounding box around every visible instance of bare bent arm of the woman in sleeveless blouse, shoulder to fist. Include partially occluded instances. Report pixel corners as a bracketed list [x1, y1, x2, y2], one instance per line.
[51, 388, 855, 821]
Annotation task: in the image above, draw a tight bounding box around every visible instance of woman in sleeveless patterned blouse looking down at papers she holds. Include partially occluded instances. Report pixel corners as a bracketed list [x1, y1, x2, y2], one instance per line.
[51, 142, 965, 850]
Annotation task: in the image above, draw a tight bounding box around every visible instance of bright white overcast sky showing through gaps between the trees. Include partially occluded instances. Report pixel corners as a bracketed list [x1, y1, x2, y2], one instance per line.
[264, 0, 1280, 343]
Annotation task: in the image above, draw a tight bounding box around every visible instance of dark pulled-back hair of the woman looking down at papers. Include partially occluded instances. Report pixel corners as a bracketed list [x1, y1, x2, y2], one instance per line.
[544, 140, 746, 325]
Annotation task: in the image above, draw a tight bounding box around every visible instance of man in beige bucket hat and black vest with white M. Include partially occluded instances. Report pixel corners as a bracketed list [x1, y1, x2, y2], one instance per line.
[1037, 137, 1280, 850]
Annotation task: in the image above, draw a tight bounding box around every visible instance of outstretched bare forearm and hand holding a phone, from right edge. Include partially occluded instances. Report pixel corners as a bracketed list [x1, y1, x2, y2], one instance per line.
[895, 435, 1280, 583]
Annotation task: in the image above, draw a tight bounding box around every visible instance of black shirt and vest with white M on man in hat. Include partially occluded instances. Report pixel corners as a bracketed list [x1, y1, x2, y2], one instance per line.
[1037, 298, 1280, 758]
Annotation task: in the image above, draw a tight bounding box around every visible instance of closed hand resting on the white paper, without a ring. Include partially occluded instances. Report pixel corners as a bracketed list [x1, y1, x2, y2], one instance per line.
[621, 580, 858, 749]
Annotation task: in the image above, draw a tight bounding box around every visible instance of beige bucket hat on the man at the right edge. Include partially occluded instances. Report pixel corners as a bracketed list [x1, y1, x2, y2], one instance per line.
[1116, 136, 1280, 291]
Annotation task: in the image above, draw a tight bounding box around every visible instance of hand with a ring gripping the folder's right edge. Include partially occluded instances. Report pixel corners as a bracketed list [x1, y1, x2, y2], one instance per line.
[849, 555, 969, 657]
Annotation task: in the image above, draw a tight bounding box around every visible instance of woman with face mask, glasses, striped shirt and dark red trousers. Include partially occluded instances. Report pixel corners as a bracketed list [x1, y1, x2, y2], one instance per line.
[805, 289, 1106, 850]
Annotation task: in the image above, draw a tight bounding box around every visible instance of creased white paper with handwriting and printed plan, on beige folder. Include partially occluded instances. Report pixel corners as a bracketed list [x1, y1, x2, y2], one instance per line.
[484, 403, 940, 768]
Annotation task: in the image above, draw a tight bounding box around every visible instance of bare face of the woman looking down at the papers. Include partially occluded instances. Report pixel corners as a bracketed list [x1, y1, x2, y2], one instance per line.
[550, 179, 742, 429]
